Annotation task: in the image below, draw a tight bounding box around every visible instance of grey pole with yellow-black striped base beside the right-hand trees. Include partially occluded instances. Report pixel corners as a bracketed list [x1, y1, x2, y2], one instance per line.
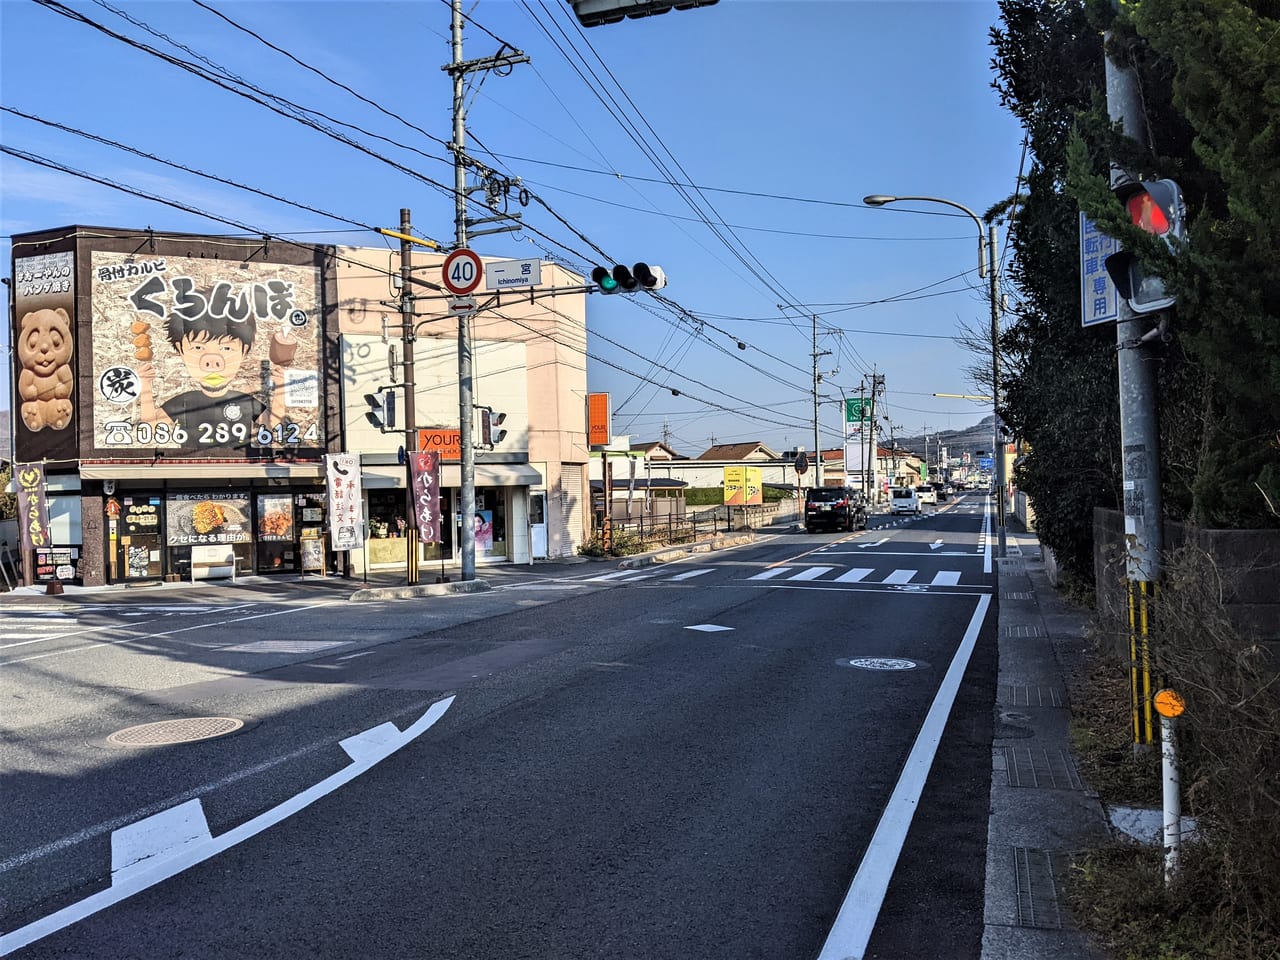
[1105, 24, 1164, 750]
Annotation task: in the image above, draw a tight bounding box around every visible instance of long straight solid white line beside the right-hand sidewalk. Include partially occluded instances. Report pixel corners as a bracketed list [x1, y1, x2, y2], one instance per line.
[818, 596, 991, 960]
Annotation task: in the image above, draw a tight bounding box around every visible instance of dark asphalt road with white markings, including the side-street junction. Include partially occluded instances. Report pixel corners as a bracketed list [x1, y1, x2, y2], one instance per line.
[0, 497, 996, 960]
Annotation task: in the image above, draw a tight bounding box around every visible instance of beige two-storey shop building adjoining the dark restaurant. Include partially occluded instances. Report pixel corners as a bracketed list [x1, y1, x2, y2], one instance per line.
[337, 247, 590, 570]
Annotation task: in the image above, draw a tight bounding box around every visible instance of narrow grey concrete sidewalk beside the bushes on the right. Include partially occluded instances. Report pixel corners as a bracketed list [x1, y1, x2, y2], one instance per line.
[982, 527, 1110, 960]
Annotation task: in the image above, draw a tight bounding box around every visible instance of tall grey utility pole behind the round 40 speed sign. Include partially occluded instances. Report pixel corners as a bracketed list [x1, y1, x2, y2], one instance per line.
[452, 0, 476, 580]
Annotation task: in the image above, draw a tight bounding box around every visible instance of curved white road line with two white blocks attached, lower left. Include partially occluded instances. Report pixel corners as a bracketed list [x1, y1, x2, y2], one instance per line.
[0, 696, 453, 956]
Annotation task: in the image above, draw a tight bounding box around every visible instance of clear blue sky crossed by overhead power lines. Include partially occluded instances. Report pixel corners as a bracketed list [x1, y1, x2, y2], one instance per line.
[0, 0, 1025, 454]
